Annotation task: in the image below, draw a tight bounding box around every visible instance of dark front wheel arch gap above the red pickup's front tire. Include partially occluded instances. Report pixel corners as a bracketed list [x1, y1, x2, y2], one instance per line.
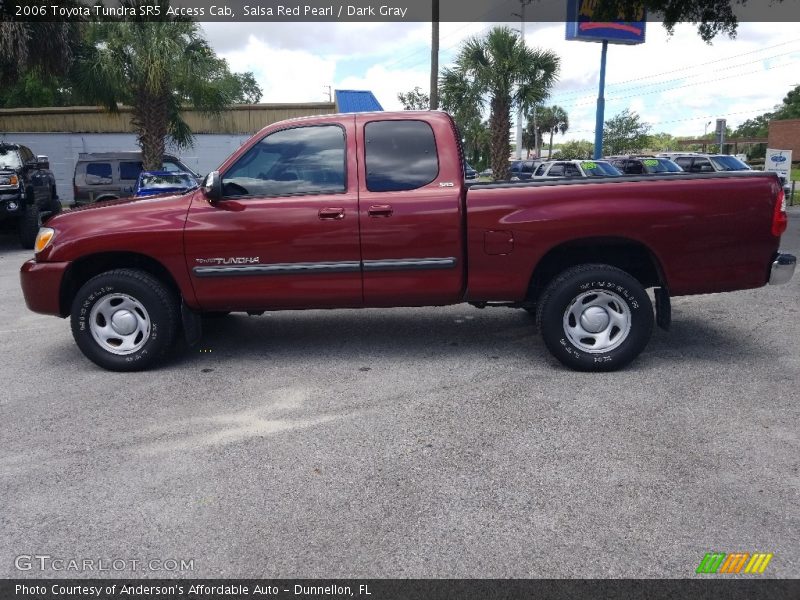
[59, 252, 183, 317]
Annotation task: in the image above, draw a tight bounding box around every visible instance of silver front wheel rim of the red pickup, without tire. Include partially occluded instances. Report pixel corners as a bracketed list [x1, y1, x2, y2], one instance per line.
[89, 294, 150, 355]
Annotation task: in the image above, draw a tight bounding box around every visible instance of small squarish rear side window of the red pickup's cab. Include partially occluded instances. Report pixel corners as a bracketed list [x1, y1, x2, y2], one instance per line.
[364, 121, 439, 192]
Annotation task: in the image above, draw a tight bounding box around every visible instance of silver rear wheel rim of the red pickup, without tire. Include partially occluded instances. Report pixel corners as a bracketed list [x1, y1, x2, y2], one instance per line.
[563, 290, 631, 354]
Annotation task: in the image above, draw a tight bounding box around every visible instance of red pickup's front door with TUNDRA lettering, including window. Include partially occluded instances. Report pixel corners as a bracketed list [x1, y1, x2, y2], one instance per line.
[185, 117, 362, 310]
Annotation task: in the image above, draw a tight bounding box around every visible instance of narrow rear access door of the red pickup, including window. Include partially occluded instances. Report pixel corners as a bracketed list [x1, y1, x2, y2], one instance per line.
[356, 113, 465, 306]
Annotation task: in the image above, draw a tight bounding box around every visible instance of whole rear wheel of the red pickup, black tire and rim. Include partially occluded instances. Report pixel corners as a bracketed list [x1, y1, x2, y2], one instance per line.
[536, 264, 654, 371]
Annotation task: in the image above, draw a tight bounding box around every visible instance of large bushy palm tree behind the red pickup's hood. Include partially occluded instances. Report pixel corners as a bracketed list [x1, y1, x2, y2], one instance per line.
[75, 7, 241, 169]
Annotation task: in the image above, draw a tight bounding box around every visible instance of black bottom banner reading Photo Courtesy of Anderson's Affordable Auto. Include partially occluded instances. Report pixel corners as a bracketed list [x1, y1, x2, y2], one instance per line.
[0, 576, 800, 600]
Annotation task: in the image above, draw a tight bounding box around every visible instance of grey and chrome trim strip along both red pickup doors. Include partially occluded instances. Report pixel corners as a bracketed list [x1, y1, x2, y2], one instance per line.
[192, 257, 458, 277]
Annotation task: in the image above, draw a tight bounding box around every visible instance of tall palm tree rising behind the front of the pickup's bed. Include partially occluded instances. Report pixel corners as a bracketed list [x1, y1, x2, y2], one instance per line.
[442, 27, 560, 179]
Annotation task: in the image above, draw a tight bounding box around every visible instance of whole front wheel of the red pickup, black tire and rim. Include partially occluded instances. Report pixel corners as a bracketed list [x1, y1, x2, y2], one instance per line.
[71, 269, 180, 371]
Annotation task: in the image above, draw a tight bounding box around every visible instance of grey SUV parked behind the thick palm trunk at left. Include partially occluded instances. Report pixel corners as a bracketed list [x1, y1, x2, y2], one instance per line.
[72, 152, 201, 206]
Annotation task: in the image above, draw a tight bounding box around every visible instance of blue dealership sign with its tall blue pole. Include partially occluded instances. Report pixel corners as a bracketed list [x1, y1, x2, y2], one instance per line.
[567, 0, 647, 159]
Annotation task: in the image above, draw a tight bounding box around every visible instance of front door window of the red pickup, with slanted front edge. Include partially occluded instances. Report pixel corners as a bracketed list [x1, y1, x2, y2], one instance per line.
[222, 125, 345, 197]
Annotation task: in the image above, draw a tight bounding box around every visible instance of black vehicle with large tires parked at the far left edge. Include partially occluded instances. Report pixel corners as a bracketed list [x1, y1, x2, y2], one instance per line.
[0, 142, 61, 248]
